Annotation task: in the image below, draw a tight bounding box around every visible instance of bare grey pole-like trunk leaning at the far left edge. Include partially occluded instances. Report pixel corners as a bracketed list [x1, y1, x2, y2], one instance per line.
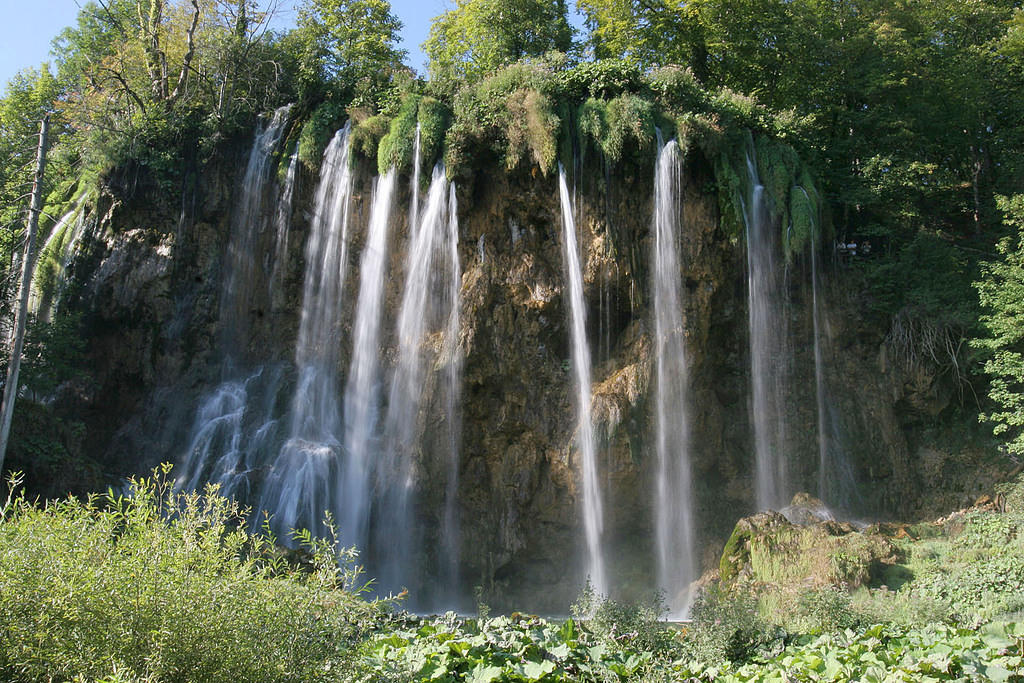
[0, 115, 50, 472]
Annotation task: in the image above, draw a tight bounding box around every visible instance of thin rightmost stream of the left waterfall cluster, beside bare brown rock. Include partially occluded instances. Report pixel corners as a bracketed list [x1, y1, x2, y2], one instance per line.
[440, 184, 462, 600]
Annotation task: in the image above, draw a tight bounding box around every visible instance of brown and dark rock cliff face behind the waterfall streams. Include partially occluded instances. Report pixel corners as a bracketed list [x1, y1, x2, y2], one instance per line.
[49, 125, 988, 611]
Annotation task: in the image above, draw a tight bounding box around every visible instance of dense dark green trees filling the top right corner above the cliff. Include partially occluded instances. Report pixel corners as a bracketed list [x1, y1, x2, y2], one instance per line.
[580, 0, 1024, 243]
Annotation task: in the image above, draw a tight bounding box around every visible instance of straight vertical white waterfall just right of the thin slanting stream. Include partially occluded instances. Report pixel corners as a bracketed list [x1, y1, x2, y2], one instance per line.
[652, 140, 698, 616]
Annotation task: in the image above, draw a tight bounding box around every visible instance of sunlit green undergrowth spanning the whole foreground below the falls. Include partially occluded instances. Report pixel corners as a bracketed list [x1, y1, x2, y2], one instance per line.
[6, 469, 1024, 683]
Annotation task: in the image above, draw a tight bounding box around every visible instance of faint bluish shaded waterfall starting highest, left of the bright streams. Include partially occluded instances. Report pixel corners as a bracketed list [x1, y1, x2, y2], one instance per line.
[220, 105, 291, 356]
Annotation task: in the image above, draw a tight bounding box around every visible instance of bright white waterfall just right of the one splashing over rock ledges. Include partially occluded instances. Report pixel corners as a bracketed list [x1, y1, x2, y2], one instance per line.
[338, 168, 397, 548]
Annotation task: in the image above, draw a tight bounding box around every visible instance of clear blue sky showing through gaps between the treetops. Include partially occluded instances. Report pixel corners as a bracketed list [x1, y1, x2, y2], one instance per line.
[0, 0, 455, 89]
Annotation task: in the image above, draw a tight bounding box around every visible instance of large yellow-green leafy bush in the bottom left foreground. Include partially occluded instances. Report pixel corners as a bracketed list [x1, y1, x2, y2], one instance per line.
[0, 467, 377, 682]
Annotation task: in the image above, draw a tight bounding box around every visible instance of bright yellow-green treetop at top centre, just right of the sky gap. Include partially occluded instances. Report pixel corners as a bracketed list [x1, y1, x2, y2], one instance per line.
[423, 0, 572, 82]
